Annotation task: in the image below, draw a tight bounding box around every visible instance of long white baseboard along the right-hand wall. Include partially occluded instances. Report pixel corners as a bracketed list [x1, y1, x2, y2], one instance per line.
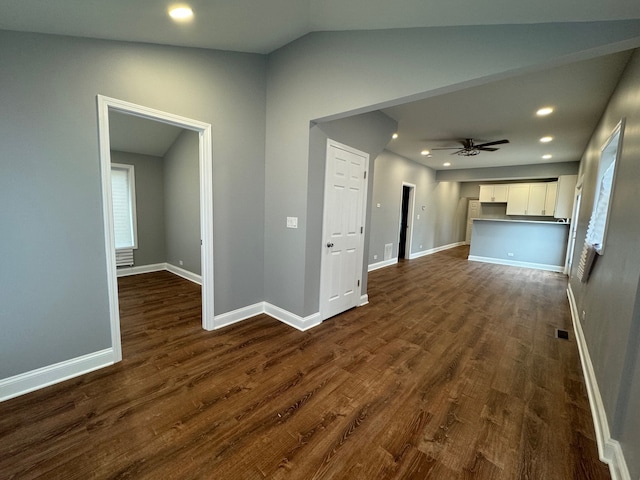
[567, 284, 631, 480]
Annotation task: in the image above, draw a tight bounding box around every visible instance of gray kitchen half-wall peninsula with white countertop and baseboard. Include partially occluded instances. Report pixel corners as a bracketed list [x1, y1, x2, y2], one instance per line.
[469, 218, 569, 272]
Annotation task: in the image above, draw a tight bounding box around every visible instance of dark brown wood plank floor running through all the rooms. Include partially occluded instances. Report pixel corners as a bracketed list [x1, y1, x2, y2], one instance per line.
[0, 247, 610, 480]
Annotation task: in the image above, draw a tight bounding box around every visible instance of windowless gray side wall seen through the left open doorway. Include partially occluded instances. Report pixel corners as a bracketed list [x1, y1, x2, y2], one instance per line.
[164, 130, 202, 275]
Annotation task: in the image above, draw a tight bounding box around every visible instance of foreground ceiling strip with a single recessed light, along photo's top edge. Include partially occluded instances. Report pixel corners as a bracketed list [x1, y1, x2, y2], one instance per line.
[0, 0, 640, 53]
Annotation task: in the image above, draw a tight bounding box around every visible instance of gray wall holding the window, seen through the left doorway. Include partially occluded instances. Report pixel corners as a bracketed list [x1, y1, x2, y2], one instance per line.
[111, 150, 167, 266]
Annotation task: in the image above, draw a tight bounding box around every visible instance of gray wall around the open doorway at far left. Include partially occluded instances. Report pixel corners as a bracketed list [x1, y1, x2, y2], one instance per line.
[0, 32, 266, 378]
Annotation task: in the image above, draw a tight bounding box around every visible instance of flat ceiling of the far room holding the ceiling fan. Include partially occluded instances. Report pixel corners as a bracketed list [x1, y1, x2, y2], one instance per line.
[382, 51, 631, 170]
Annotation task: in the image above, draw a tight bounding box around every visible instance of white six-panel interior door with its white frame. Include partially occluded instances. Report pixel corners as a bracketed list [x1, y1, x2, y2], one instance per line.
[320, 140, 369, 320]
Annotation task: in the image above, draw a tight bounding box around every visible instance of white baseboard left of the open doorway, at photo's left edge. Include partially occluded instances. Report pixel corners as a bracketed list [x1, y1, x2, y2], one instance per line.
[0, 348, 114, 402]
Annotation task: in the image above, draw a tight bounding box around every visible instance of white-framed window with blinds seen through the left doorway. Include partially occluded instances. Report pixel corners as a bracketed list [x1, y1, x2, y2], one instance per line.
[111, 163, 138, 250]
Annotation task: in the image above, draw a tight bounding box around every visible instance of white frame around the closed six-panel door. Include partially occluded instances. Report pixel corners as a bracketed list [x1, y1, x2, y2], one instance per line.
[320, 138, 369, 321]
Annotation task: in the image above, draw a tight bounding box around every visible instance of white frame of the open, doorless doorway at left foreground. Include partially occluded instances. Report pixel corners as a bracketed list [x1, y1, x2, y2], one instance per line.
[97, 95, 214, 362]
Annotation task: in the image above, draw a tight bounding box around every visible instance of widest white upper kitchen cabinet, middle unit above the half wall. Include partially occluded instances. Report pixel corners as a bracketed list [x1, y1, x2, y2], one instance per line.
[507, 182, 558, 217]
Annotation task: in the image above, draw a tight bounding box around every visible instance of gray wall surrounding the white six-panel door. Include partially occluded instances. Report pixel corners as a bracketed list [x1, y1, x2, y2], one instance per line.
[304, 112, 398, 315]
